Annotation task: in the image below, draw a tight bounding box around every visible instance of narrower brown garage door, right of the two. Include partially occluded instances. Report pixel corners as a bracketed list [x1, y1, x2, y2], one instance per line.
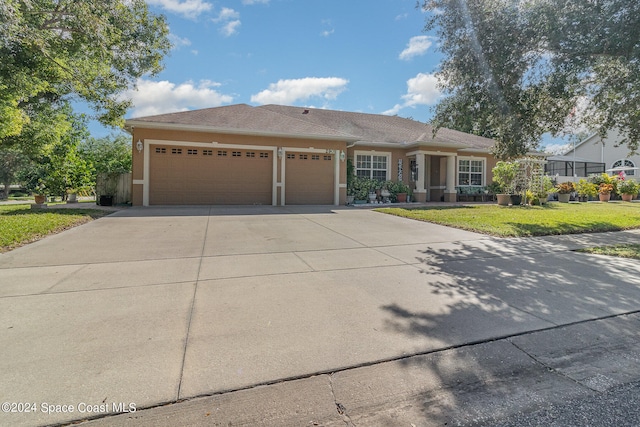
[285, 152, 334, 205]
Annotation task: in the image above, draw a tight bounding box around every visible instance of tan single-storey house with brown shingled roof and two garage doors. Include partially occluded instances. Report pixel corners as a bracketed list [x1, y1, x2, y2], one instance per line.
[126, 104, 496, 206]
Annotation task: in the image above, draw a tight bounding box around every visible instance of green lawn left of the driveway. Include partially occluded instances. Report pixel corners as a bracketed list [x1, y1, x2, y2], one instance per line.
[0, 205, 110, 252]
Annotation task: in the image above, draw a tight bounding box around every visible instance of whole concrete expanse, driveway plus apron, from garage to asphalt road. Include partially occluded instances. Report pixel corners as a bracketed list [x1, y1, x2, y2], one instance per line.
[0, 206, 640, 426]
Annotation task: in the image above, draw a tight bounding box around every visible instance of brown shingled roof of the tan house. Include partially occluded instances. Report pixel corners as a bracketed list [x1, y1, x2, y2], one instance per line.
[126, 104, 493, 151]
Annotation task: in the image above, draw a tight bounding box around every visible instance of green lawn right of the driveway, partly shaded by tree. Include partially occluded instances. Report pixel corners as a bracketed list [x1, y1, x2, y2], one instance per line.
[376, 202, 640, 237]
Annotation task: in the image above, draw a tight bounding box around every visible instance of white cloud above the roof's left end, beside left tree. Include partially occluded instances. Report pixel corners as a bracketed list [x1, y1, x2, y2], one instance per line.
[124, 79, 233, 117]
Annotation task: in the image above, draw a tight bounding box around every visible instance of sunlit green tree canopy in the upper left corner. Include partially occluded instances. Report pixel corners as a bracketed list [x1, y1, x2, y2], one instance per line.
[0, 0, 170, 140]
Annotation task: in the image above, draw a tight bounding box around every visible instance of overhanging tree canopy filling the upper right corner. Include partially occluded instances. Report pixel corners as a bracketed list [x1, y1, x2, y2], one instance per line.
[422, 0, 640, 159]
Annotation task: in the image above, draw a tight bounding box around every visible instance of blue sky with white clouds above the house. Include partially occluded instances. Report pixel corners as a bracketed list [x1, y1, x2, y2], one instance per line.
[91, 0, 568, 153]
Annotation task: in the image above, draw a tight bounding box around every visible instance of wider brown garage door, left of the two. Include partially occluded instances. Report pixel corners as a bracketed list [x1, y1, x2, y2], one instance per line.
[149, 145, 273, 205]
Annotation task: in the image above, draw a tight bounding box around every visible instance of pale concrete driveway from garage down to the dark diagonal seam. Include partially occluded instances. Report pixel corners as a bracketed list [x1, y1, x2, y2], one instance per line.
[0, 206, 640, 425]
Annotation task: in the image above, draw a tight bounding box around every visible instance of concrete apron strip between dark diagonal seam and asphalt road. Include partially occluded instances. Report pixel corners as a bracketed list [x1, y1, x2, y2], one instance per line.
[80, 313, 640, 427]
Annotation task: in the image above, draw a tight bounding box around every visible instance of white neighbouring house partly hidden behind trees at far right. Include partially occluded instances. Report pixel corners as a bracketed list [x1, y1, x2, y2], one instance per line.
[566, 131, 640, 179]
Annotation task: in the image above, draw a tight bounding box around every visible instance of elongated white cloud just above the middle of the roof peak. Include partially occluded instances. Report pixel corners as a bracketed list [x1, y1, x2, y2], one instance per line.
[251, 77, 349, 105]
